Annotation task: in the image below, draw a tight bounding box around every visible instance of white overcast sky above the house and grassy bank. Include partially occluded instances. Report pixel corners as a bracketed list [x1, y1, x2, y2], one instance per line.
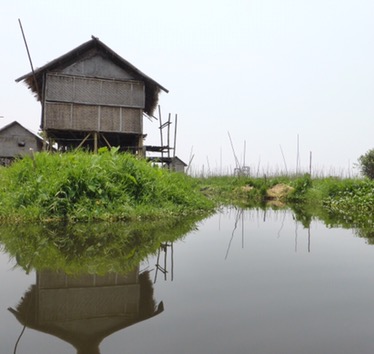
[0, 0, 374, 174]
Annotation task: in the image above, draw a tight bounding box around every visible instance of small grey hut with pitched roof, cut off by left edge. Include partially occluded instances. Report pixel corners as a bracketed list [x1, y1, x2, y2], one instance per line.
[0, 121, 43, 166]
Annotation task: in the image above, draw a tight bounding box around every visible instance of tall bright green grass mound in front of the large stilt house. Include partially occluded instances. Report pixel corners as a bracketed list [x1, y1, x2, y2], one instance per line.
[0, 149, 214, 222]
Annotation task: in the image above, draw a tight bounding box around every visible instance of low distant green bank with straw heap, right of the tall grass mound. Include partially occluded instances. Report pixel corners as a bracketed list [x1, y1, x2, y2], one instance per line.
[200, 175, 374, 224]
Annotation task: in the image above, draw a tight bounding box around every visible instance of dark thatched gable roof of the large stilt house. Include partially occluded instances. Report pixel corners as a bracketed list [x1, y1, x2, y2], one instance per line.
[16, 36, 169, 115]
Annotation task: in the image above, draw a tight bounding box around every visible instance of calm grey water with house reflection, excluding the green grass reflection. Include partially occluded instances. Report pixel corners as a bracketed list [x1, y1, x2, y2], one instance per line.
[0, 209, 374, 354]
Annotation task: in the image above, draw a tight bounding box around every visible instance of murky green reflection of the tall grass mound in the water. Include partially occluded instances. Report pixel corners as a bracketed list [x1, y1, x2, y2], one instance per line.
[0, 213, 205, 274]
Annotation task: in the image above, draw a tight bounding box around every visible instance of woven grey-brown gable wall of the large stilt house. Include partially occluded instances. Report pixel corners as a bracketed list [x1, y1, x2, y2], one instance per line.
[42, 55, 145, 135]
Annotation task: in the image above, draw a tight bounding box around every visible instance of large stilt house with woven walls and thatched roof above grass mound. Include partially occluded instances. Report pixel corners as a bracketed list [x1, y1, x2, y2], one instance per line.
[16, 37, 168, 153]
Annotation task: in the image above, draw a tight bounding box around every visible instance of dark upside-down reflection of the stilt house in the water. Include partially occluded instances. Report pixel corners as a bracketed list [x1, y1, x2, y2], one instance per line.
[9, 268, 163, 354]
